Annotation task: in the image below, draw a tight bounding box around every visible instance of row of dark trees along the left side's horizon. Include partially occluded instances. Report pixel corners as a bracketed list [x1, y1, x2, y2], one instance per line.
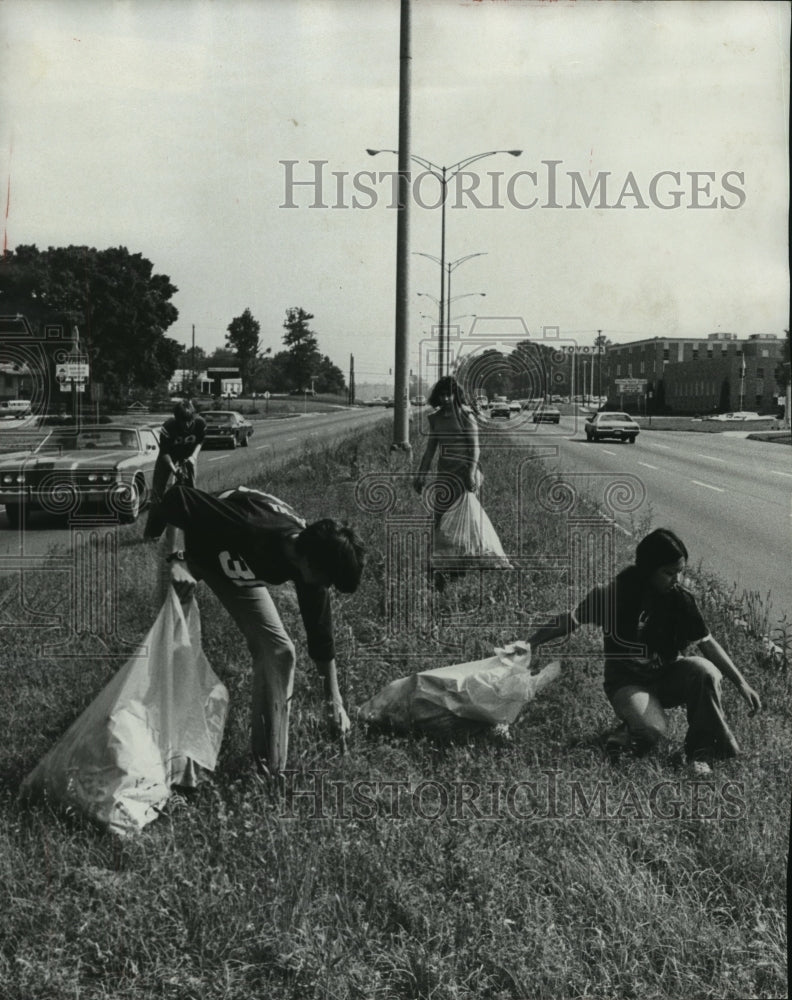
[0, 245, 346, 401]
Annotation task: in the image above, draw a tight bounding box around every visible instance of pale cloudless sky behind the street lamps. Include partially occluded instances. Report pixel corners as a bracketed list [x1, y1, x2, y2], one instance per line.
[0, 0, 790, 382]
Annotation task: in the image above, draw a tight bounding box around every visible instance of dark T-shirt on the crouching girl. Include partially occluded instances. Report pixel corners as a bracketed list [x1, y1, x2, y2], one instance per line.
[574, 566, 709, 688]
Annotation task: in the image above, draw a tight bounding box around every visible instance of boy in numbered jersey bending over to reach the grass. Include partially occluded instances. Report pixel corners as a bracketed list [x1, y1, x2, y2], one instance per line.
[152, 486, 365, 774]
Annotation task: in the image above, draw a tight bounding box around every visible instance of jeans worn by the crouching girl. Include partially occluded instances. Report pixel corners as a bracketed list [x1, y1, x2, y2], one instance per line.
[606, 656, 740, 760]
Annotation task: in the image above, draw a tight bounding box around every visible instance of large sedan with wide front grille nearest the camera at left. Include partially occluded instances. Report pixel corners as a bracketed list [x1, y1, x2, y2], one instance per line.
[0, 424, 159, 528]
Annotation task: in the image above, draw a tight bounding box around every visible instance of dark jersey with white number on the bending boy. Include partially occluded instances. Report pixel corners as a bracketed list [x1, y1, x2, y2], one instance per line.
[161, 486, 335, 660]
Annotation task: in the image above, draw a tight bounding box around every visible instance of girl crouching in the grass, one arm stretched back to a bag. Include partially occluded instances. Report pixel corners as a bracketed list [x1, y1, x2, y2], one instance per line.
[529, 528, 762, 775]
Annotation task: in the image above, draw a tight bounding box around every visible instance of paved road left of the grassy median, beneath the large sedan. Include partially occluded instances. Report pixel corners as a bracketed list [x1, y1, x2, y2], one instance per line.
[0, 407, 393, 575]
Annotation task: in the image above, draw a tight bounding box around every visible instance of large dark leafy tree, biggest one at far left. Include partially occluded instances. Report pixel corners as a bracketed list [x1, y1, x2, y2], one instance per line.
[0, 246, 182, 398]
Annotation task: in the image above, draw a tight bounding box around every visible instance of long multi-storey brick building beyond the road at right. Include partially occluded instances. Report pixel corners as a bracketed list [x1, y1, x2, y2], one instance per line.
[603, 333, 784, 414]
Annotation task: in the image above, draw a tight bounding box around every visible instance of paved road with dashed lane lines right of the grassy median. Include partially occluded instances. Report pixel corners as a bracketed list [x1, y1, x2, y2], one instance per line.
[492, 417, 792, 620]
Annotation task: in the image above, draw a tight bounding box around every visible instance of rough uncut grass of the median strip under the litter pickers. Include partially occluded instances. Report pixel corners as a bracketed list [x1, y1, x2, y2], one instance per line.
[0, 420, 792, 1000]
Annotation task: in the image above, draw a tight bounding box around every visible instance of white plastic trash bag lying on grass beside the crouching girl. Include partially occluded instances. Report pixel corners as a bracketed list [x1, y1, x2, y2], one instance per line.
[358, 642, 561, 732]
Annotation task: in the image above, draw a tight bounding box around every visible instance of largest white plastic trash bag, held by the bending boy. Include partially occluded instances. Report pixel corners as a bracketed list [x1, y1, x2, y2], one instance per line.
[21, 587, 228, 835]
